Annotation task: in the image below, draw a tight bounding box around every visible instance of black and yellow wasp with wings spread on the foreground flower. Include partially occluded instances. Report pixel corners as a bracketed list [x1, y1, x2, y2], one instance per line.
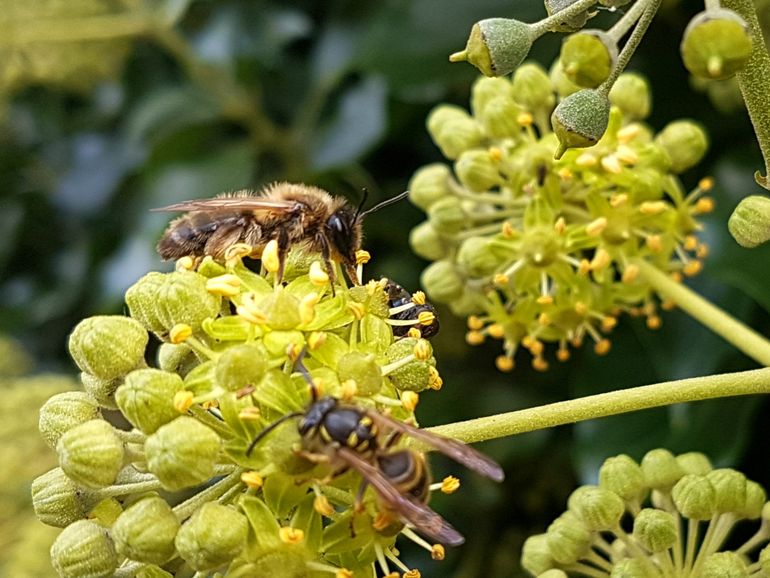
[246, 361, 504, 546]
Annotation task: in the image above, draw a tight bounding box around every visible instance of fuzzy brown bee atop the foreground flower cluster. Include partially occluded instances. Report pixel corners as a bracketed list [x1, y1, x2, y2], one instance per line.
[155, 182, 407, 284]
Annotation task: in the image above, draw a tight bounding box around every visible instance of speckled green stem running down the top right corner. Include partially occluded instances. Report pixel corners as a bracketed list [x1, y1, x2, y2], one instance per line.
[722, 0, 770, 189]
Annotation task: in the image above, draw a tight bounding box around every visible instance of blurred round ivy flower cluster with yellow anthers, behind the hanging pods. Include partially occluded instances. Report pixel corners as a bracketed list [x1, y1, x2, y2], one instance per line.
[409, 64, 713, 371]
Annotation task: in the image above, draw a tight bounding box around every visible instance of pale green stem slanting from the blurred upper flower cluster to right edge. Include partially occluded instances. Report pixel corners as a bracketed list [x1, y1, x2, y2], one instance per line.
[630, 259, 770, 366]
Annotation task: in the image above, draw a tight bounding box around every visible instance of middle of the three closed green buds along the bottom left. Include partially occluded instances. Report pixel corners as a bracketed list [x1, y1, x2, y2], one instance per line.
[111, 496, 180, 564]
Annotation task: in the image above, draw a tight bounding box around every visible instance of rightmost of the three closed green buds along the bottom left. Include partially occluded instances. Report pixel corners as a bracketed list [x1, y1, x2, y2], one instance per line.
[175, 502, 248, 572]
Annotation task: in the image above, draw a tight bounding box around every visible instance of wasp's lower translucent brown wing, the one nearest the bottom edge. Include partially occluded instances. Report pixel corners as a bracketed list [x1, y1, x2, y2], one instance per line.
[337, 447, 465, 546]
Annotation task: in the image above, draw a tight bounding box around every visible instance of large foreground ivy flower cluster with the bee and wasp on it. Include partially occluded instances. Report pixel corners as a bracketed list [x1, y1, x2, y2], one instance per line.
[32, 242, 450, 578]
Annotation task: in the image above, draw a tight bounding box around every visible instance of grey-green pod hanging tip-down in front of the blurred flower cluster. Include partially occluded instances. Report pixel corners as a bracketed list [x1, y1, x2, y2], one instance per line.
[551, 89, 610, 159]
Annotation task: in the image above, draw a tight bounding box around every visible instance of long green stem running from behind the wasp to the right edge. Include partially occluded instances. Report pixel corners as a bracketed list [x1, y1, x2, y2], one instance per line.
[424, 368, 770, 449]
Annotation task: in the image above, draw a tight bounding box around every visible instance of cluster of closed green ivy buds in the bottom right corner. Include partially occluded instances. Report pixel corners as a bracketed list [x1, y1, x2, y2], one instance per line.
[521, 449, 770, 578]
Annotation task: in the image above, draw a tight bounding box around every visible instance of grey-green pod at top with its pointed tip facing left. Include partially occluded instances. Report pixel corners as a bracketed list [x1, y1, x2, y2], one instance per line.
[449, 18, 533, 76]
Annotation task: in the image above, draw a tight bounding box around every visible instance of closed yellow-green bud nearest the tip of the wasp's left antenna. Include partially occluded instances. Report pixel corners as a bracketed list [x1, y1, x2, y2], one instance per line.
[144, 416, 221, 491]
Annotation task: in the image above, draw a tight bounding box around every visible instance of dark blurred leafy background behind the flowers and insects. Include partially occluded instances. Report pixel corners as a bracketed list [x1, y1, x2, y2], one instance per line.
[0, 0, 770, 578]
